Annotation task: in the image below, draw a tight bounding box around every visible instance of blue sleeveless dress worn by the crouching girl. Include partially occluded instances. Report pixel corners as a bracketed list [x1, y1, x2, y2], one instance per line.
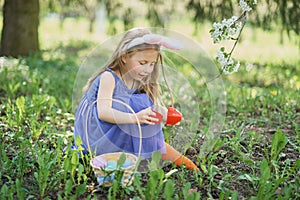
[74, 68, 166, 159]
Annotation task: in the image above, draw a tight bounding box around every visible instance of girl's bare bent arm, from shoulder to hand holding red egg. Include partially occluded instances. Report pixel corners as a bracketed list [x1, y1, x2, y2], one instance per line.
[97, 72, 158, 125]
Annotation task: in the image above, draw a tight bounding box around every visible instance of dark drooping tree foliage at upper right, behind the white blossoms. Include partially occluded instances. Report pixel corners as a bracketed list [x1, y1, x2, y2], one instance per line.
[186, 0, 300, 43]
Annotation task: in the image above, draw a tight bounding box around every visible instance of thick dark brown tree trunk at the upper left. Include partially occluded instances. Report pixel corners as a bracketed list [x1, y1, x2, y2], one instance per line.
[0, 0, 39, 57]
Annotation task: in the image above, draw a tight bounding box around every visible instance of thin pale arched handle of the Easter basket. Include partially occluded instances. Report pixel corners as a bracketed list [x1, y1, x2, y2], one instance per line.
[85, 98, 143, 158]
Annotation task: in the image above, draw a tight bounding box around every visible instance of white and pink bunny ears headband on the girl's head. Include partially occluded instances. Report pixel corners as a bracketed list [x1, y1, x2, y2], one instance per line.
[122, 34, 183, 51]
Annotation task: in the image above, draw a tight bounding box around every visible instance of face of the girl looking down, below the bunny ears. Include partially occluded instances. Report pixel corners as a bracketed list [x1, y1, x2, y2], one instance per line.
[122, 49, 158, 80]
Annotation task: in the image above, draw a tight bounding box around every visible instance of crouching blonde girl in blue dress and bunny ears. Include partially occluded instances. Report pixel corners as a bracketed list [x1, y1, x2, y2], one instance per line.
[74, 28, 199, 171]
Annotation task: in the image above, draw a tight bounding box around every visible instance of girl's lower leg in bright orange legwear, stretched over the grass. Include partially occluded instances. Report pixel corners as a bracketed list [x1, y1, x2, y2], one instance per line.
[162, 143, 199, 171]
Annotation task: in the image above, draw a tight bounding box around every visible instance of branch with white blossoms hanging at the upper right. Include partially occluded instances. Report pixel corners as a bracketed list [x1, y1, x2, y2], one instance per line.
[210, 0, 257, 78]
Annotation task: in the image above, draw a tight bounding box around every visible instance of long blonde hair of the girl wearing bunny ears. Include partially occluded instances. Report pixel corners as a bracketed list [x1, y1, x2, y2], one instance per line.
[83, 28, 163, 103]
